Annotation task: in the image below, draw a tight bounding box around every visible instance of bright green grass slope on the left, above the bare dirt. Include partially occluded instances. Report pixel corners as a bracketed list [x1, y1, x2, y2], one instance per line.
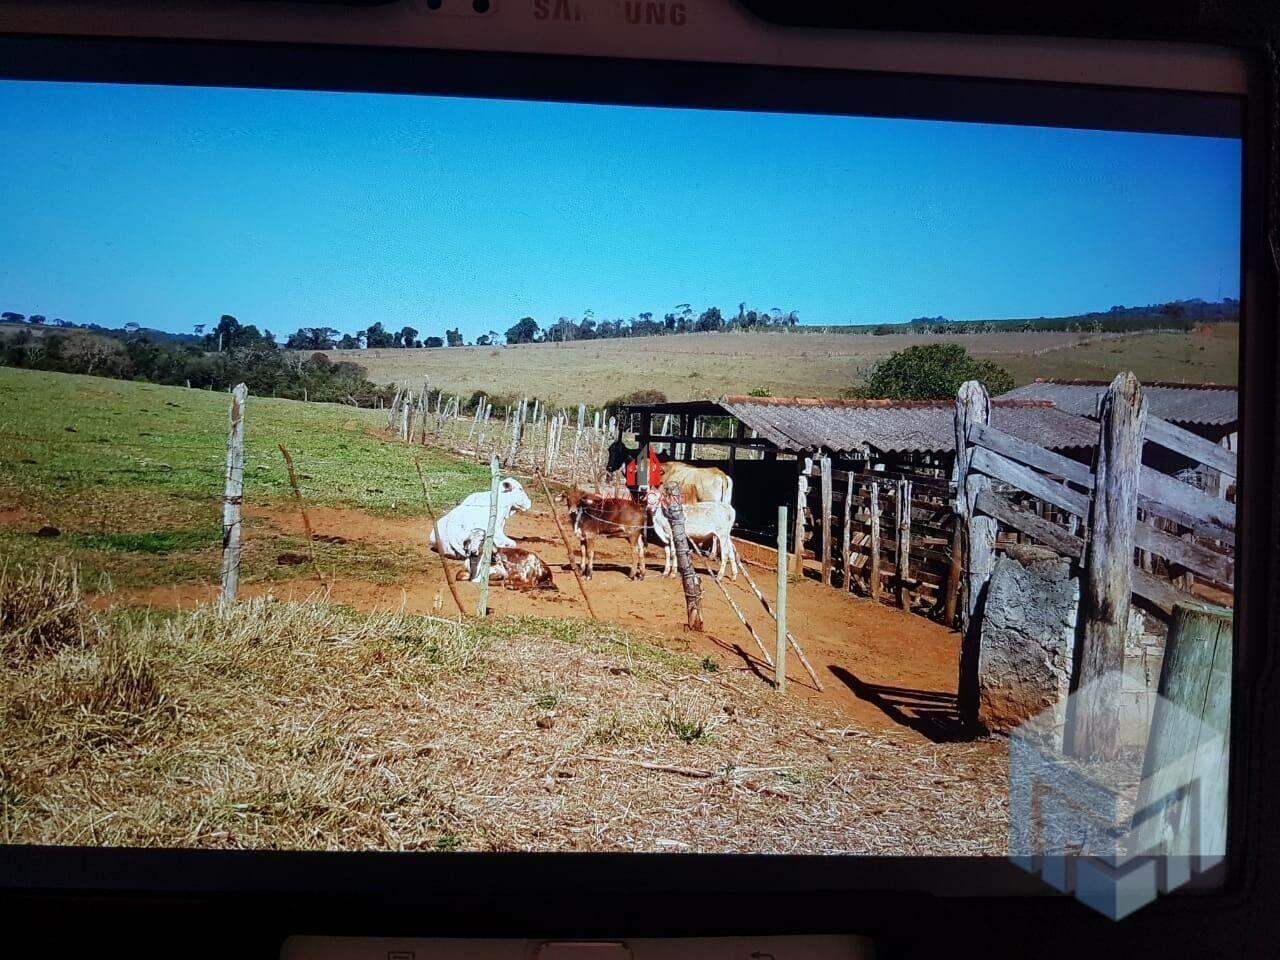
[0, 367, 488, 519]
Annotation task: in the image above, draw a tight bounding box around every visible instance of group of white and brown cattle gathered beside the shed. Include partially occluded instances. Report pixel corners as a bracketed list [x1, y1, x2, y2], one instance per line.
[429, 442, 737, 590]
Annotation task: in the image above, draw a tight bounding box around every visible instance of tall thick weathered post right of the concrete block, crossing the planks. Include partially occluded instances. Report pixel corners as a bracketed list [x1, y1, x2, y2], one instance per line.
[1068, 372, 1147, 760]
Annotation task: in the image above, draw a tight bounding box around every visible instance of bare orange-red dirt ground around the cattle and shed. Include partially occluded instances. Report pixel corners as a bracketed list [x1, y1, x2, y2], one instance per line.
[110, 507, 959, 741]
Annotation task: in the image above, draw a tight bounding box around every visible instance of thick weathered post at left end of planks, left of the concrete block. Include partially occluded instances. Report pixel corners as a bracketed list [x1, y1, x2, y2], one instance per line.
[955, 380, 996, 726]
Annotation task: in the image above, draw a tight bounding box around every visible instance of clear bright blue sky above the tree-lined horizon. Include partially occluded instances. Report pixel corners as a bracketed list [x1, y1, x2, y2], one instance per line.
[0, 82, 1240, 339]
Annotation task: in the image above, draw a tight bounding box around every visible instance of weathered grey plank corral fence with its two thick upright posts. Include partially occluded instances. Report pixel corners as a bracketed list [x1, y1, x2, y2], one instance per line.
[955, 374, 1236, 756]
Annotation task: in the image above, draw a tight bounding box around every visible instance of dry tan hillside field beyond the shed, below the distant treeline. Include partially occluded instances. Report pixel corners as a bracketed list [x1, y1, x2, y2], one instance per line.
[345, 324, 1239, 403]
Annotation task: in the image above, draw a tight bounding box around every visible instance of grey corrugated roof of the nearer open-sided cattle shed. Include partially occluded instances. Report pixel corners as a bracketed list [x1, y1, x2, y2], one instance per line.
[719, 396, 1098, 454]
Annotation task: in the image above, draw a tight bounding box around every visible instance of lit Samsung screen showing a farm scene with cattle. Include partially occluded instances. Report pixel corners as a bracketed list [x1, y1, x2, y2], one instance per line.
[0, 69, 1242, 901]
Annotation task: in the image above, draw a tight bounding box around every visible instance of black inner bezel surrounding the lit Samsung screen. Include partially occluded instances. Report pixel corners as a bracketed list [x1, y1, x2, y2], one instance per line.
[0, 30, 1276, 936]
